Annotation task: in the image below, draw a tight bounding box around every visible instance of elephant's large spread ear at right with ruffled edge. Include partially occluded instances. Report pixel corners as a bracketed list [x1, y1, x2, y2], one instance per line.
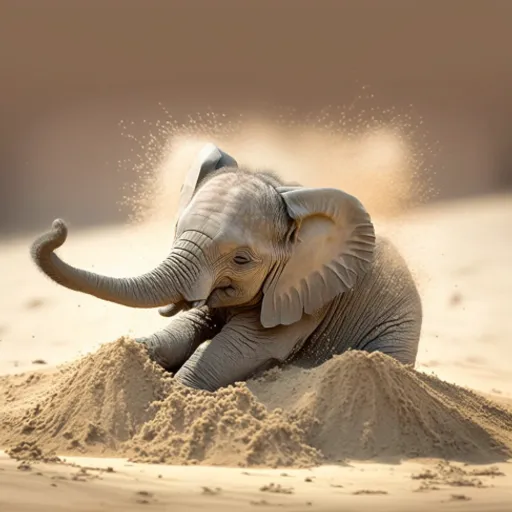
[261, 187, 375, 327]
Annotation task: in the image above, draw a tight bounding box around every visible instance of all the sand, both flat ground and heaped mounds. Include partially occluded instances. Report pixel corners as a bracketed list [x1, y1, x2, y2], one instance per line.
[0, 190, 512, 511]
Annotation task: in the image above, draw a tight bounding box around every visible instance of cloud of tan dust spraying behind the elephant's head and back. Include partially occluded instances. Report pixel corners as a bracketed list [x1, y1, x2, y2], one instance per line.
[118, 101, 436, 231]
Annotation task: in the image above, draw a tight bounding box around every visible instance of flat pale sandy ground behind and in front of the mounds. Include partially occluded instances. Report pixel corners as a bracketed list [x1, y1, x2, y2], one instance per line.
[0, 192, 512, 512]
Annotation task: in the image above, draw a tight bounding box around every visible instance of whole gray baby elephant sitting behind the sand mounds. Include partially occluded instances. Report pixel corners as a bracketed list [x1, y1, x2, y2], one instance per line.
[32, 145, 422, 391]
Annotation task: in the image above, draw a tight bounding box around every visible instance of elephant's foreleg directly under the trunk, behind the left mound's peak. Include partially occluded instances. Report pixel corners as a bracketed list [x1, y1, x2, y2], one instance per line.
[136, 307, 223, 373]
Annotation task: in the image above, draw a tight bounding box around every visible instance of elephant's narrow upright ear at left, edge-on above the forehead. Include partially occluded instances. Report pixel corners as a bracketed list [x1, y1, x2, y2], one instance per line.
[178, 143, 238, 218]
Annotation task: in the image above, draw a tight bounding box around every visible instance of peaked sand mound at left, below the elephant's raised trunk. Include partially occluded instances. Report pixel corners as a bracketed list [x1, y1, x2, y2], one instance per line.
[2, 338, 170, 452]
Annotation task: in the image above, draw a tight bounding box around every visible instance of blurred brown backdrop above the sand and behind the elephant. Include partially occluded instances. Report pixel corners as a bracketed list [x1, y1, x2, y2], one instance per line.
[0, 0, 512, 234]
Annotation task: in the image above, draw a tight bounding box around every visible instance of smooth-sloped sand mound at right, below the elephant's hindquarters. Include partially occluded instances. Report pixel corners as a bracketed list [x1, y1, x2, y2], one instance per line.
[250, 351, 512, 461]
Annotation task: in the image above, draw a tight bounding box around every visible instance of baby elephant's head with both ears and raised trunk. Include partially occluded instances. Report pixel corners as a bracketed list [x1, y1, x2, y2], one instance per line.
[32, 144, 375, 327]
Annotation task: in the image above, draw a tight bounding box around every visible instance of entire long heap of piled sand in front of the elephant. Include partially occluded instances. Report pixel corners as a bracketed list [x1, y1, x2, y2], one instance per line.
[0, 338, 512, 466]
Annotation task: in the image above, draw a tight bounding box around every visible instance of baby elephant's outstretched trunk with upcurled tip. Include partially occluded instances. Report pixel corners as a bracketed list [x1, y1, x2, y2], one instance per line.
[31, 219, 190, 308]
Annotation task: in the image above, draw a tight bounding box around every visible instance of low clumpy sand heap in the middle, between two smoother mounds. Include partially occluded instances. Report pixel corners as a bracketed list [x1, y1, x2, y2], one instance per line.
[130, 385, 320, 467]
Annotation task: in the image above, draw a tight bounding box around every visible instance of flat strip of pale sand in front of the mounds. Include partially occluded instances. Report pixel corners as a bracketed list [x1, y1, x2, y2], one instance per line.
[0, 457, 512, 512]
